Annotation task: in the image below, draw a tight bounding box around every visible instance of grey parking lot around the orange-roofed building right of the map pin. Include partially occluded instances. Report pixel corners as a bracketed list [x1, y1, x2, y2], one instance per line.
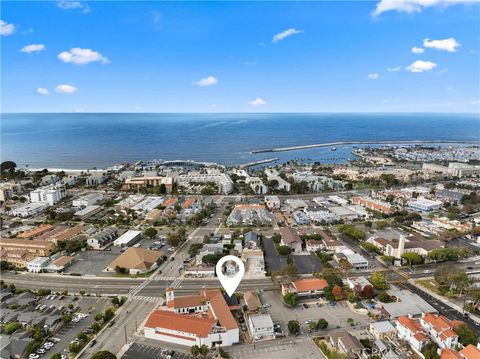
[259, 291, 369, 333]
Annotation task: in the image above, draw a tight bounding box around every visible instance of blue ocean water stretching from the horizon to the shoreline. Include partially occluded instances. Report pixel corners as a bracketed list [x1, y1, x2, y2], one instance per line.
[0, 113, 480, 169]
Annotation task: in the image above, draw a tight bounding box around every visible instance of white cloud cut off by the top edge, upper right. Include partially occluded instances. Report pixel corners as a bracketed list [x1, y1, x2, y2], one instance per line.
[372, 0, 478, 16]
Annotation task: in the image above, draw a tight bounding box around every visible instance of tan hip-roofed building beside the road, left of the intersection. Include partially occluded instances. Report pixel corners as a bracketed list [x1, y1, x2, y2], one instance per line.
[106, 248, 162, 274]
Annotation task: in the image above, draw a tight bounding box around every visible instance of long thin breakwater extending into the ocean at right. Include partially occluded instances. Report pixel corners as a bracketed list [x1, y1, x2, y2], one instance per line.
[250, 140, 480, 155]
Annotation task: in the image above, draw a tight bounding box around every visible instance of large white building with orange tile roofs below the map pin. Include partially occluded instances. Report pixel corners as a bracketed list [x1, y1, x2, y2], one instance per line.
[144, 288, 240, 347]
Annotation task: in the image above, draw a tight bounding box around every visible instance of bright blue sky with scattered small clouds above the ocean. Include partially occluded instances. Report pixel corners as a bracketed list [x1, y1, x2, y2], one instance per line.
[0, 0, 480, 113]
